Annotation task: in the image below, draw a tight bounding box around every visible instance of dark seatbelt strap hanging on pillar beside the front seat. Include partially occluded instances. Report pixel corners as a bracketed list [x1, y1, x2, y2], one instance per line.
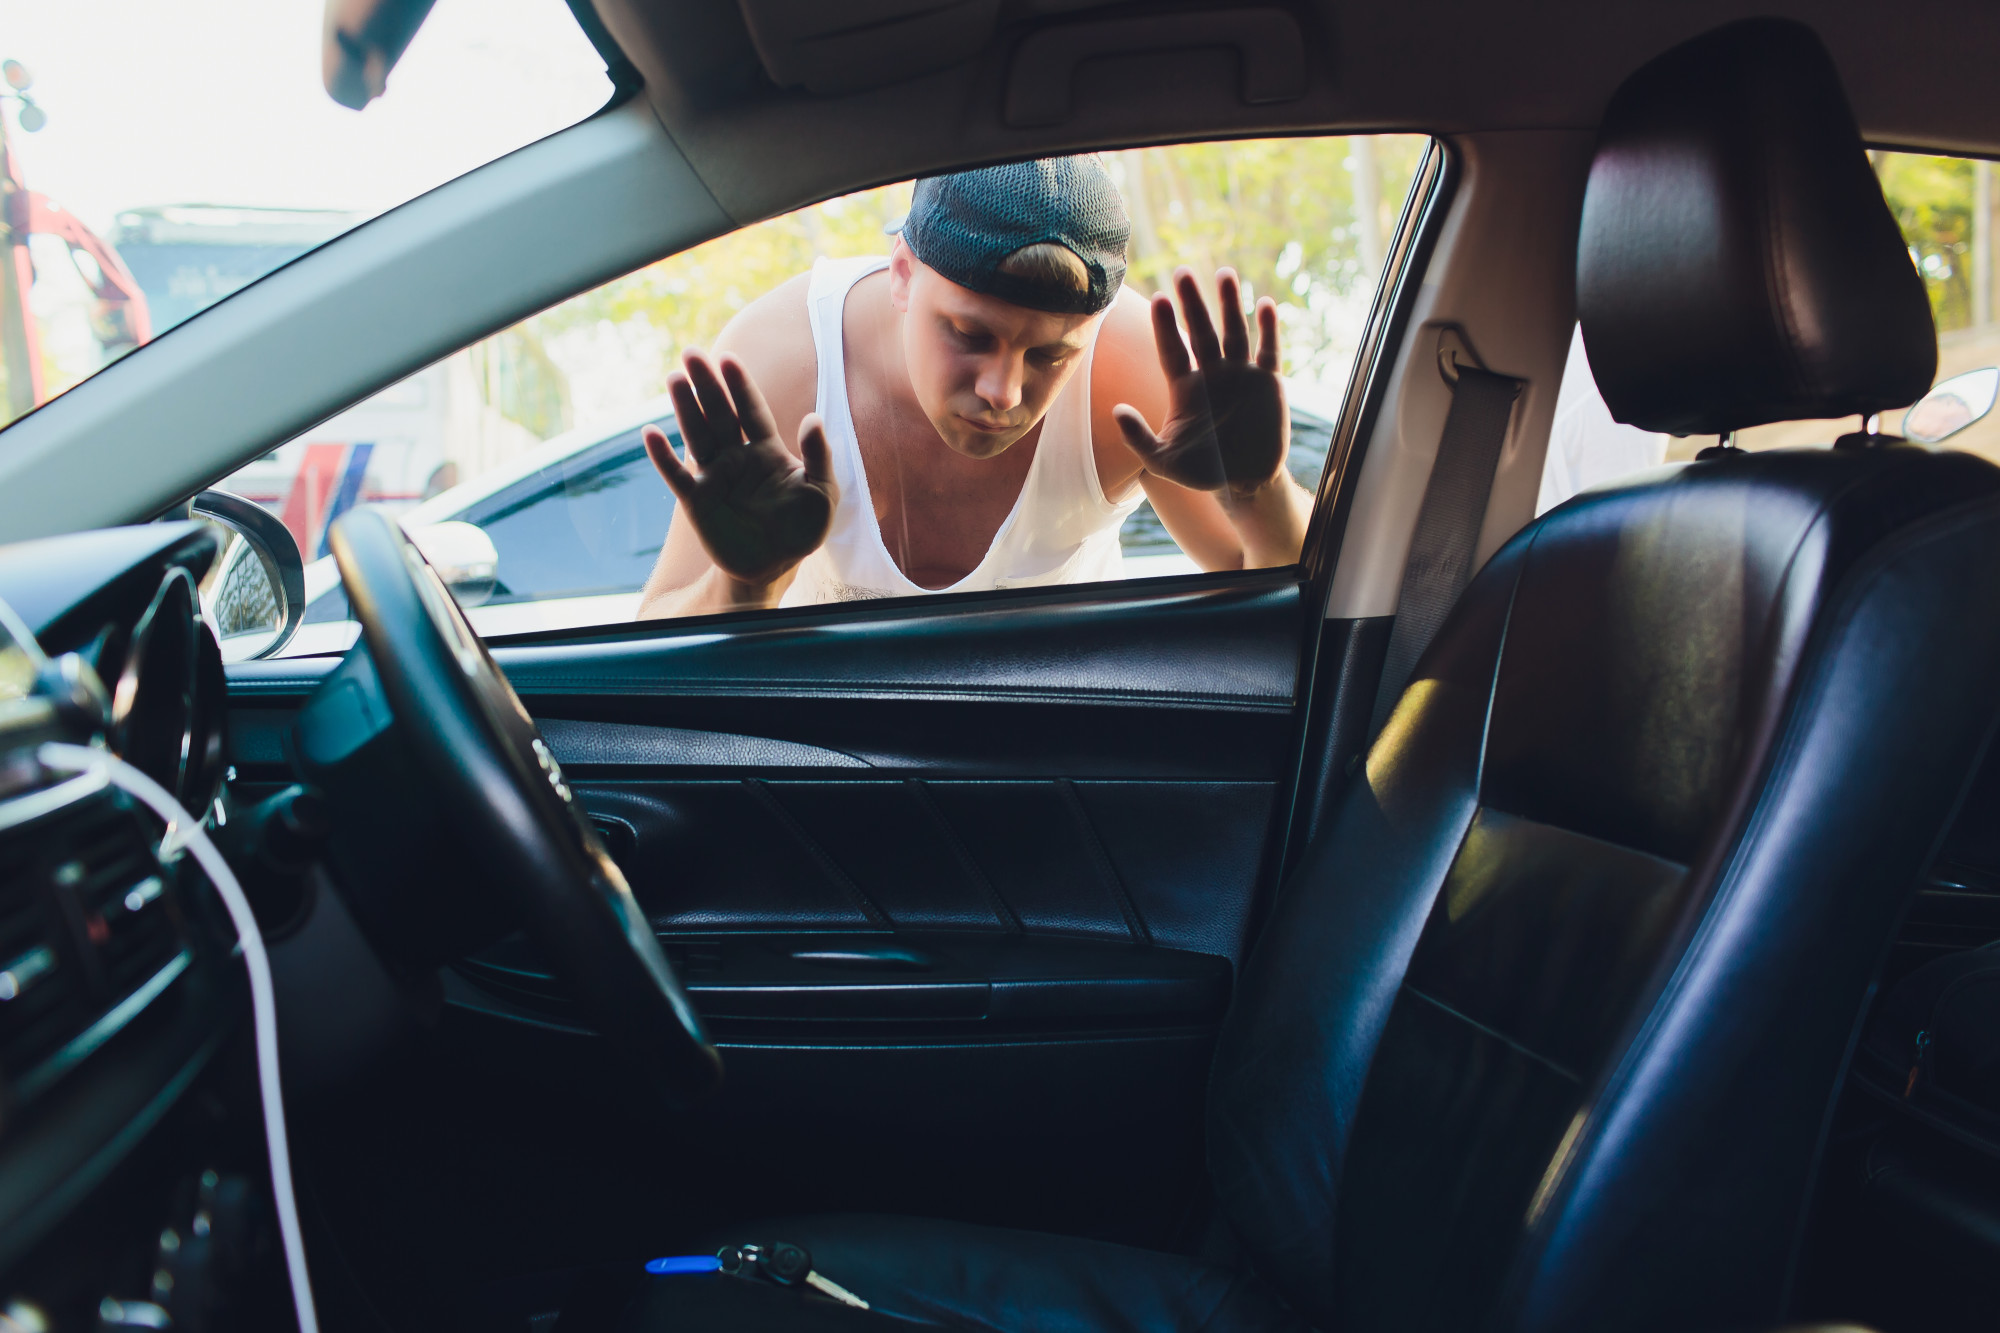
[1368, 362, 1522, 735]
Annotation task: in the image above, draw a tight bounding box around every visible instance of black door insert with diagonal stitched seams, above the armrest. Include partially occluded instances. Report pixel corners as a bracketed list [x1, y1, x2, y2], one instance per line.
[572, 772, 1272, 948]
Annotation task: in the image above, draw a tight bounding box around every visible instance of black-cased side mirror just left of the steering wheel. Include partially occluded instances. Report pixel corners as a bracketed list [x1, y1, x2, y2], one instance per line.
[188, 490, 306, 662]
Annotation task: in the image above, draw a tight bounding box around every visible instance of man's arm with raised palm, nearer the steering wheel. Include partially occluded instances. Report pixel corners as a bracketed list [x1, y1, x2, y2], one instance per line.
[638, 276, 834, 620]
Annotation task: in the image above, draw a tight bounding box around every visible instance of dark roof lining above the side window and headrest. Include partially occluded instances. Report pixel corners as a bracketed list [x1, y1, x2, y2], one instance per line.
[596, 0, 2000, 222]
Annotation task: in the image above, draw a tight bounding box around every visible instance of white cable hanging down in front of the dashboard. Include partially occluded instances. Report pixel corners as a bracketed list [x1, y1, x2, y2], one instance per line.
[36, 743, 320, 1333]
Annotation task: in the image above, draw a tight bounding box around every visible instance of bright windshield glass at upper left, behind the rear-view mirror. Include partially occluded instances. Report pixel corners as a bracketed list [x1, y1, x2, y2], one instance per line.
[0, 0, 612, 424]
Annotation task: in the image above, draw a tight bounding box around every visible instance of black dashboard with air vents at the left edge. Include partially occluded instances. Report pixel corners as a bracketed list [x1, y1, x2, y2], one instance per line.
[0, 522, 288, 1333]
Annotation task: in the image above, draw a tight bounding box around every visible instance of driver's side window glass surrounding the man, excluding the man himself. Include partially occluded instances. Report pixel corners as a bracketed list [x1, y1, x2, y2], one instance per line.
[246, 136, 1428, 650]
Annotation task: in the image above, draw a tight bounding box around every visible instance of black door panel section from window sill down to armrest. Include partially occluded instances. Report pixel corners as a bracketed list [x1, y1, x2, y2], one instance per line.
[482, 578, 1300, 961]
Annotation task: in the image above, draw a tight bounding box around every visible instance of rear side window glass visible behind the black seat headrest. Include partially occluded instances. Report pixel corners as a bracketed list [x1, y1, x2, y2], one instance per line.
[1536, 152, 2000, 512]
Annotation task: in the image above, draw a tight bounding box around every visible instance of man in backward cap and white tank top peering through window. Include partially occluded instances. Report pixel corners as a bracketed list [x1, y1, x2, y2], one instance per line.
[640, 158, 1312, 616]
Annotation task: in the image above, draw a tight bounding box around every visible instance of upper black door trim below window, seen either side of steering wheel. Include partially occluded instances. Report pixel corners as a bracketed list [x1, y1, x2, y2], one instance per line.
[228, 568, 1306, 783]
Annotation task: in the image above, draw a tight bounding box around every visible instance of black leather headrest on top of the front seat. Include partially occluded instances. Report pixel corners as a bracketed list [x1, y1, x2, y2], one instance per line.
[1576, 18, 1938, 434]
